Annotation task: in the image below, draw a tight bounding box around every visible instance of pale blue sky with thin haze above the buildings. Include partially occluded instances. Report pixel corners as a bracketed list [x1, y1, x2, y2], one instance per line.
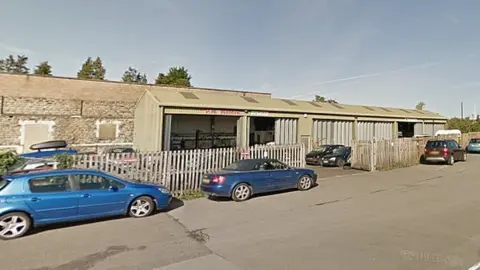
[0, 0, 480, 116]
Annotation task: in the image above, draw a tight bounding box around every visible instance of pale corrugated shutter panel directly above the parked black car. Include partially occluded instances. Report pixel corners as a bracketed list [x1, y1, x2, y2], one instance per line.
[312, 120, 354, 145]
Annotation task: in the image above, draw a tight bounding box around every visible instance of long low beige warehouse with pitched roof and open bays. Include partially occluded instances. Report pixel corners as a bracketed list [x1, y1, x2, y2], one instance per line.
[134, 88, 447, 151]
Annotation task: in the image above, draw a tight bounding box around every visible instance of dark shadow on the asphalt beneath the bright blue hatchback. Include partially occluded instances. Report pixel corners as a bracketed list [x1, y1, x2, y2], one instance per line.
[27, 197, 184, 236]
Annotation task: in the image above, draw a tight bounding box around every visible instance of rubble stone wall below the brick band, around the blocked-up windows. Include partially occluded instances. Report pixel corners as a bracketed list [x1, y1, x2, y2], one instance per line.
[0, 96, 135, 151]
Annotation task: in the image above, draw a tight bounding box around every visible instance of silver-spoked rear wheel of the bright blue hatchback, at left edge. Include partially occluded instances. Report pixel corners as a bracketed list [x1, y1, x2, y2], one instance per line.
[0, 212, 32, 240]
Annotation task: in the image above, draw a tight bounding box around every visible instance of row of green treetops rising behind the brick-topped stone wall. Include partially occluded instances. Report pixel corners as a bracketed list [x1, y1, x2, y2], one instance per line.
[0, 55, 192, 87]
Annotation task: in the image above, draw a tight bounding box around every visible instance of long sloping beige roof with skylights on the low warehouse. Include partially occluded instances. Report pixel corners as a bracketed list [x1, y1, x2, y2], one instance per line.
[147, 89, 446, 120]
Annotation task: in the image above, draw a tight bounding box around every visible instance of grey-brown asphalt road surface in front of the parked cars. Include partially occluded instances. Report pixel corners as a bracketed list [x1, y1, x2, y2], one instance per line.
[0, 156, 480, 270]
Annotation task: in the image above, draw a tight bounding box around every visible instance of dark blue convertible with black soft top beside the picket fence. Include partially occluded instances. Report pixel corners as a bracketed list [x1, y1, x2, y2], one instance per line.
[201, 159, 317, 201]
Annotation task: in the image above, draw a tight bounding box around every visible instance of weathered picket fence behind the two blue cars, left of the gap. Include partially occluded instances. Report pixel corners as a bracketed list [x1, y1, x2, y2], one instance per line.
[75, 144, 306, 195]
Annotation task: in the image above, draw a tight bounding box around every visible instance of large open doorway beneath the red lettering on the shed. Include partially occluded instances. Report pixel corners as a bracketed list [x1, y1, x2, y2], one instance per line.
[164, 114, 238, 150]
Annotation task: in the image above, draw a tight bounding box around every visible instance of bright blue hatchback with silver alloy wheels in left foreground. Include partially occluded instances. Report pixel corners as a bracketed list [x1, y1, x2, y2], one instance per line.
[0, 169, 172, 240]
